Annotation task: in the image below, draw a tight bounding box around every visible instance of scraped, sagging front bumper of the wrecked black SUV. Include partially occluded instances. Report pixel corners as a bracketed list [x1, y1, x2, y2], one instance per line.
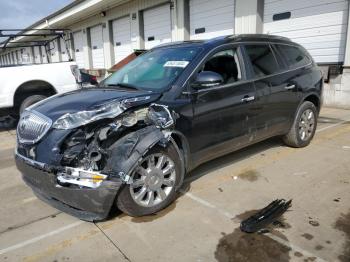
[15, 152, 123, 221]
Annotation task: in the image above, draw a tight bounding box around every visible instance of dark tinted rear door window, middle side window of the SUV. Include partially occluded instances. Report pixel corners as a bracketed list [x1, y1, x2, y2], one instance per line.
[245, 45, 279, 76]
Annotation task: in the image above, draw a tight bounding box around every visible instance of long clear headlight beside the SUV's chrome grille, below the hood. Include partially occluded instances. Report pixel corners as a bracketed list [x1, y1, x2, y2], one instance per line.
[52, 101, 126, 129]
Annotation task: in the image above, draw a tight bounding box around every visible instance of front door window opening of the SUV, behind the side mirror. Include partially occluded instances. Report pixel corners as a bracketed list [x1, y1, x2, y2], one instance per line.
[202, 48, 242, 84]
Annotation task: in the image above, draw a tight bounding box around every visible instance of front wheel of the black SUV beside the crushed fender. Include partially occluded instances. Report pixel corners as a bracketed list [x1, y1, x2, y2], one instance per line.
[116, 144, 181, 217]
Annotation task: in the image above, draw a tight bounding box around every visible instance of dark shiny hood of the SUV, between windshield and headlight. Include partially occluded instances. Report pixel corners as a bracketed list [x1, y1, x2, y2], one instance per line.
[31, 88, 161, 122]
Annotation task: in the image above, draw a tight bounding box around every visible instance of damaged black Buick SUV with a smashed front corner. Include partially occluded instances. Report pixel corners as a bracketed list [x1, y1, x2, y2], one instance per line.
[16, 35, 323, 221]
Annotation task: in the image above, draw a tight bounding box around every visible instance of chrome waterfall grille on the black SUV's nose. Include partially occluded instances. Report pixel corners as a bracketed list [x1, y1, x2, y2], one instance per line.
[17, 110, 52, 144]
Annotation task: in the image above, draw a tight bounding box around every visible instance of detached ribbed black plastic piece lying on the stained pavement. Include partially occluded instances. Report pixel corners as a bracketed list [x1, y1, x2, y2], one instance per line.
[240, 199, 292, 233]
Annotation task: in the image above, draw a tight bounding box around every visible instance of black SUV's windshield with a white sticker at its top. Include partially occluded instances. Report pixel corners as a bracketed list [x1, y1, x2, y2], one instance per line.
[103, 47, 199, 91]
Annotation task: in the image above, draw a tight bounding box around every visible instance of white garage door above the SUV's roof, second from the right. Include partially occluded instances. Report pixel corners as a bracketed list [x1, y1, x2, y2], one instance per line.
[190, 0, 235, 40]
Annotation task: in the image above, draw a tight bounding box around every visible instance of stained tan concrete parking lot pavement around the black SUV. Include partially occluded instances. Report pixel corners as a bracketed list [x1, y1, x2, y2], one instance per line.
[0, 108, 350, 262]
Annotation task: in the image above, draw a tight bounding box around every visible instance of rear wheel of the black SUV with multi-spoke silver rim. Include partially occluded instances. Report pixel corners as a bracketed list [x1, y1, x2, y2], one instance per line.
[283, 101, 318, 148]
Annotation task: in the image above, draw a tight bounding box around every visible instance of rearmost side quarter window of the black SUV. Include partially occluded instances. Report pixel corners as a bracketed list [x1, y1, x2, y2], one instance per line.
[276, 45, 311, 68]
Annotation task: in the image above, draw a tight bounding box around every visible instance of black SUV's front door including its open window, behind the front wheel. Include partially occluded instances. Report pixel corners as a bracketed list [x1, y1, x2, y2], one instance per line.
[189, 47, 255, 162]
